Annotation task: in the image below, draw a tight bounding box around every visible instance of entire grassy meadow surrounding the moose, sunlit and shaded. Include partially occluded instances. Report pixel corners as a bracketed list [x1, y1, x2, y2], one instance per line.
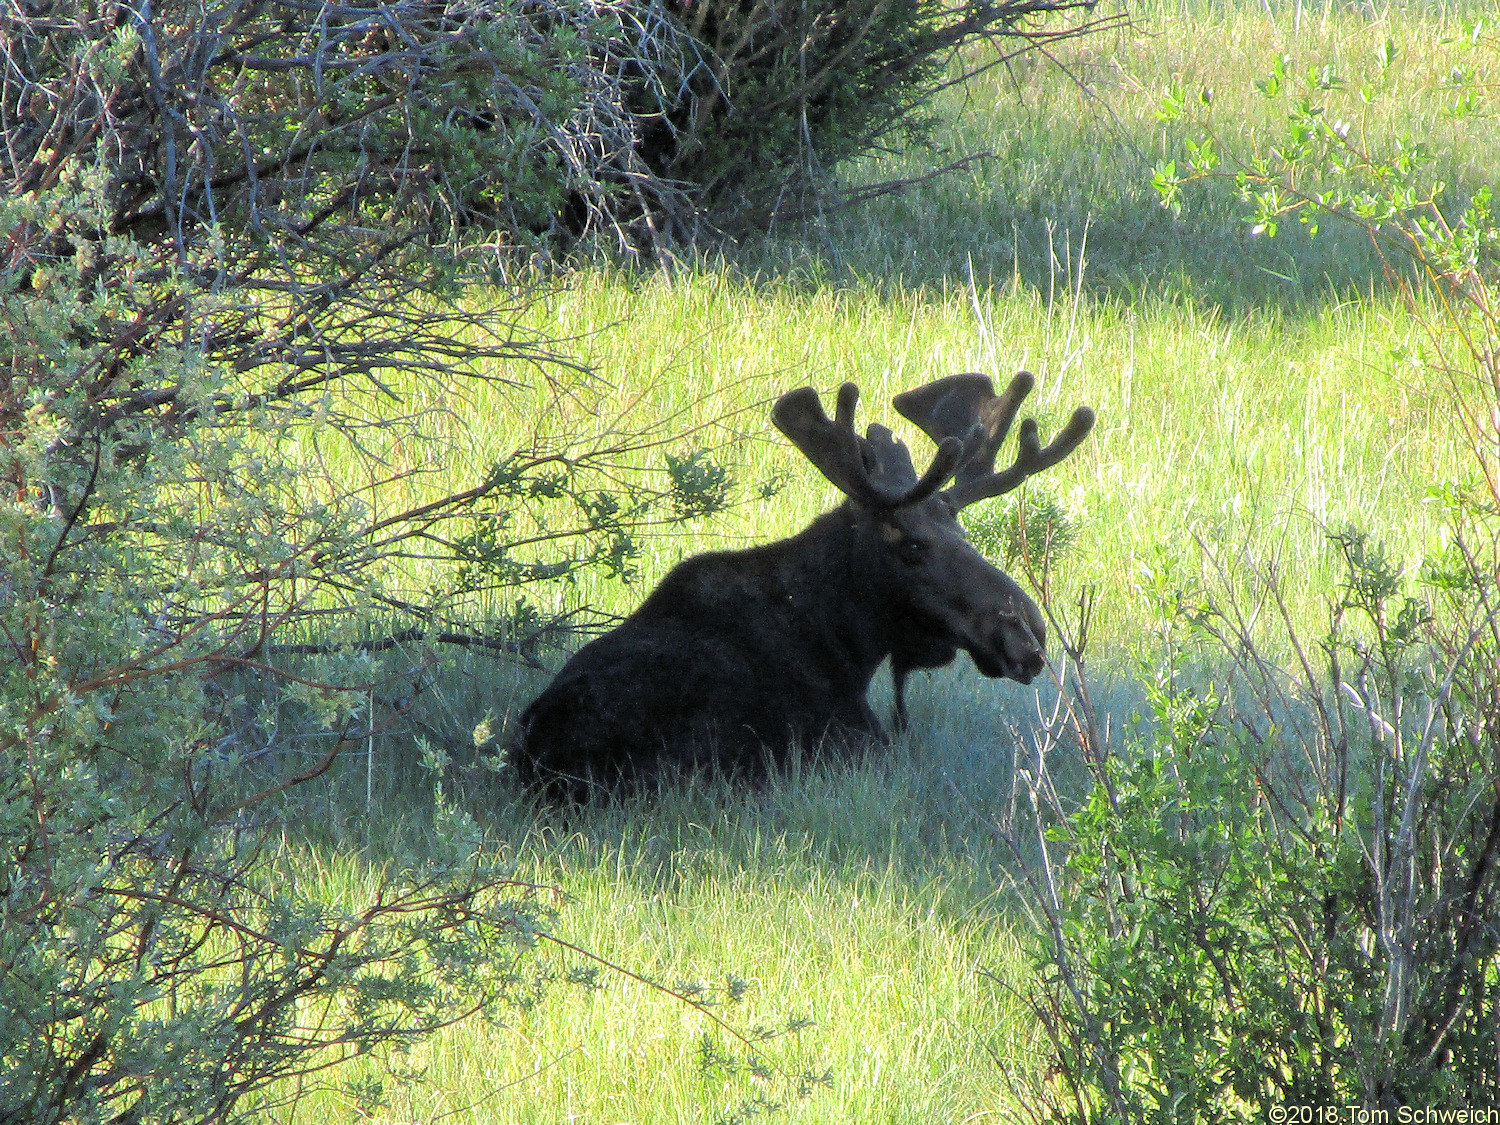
[276, 0, 1500, 1125]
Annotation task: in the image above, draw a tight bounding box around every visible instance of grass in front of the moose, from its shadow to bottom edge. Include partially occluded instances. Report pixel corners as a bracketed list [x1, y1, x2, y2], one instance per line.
[273, 660, 1128, 1122]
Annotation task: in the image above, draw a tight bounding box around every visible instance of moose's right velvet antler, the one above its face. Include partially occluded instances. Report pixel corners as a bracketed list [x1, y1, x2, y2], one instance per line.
[893, 371, 1094, 509]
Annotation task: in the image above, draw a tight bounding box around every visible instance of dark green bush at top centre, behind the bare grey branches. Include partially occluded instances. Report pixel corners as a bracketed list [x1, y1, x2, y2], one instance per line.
[633, 0, 1118, 227]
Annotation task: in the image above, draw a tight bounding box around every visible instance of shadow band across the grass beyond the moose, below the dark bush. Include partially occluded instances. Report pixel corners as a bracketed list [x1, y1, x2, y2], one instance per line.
[722, 156, 1391, 318]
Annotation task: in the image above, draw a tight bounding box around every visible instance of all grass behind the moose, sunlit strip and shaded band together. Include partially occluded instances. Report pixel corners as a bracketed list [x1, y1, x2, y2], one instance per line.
[310, 3, 1500, 644]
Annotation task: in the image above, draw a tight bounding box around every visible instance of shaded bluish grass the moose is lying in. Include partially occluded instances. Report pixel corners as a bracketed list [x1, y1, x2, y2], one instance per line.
[283, 642, 1140, 917]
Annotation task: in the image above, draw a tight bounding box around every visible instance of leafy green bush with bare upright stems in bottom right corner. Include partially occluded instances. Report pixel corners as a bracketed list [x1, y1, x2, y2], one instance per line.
[1008, 522, 1500, 1122]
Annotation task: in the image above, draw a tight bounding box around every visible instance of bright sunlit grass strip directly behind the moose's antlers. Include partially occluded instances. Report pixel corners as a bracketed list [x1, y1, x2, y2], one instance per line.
[304, 266, 1467, 644]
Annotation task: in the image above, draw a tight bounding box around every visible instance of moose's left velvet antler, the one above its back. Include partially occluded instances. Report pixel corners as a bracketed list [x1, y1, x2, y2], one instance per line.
[771, 383, 965, 509]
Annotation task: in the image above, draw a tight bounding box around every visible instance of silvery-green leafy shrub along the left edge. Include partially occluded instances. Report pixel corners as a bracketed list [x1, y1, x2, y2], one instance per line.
[0, 178, 561, 1122]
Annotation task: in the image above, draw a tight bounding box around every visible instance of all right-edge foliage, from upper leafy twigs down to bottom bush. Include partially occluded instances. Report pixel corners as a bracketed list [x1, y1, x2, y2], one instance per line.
[996, 36, 1500, 1122]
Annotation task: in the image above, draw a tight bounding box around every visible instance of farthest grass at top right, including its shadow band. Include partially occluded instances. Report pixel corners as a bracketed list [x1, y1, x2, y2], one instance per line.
[792, 0, 1500, 304]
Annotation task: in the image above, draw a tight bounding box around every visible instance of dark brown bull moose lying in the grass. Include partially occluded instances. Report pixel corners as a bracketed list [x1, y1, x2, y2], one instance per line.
[513, 372, 1094, 800]
